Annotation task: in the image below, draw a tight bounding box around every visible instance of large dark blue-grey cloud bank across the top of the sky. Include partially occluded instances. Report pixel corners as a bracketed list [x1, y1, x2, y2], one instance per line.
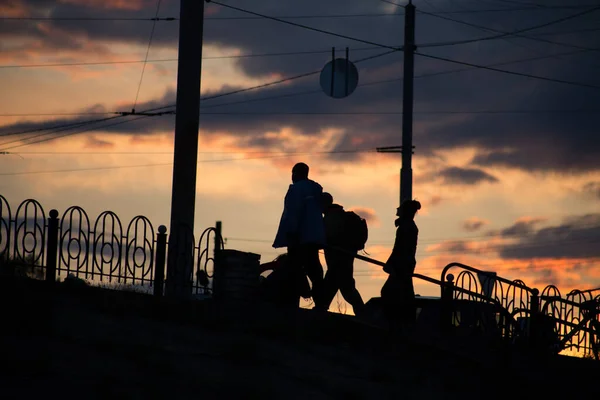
[0, 0, 600, 174]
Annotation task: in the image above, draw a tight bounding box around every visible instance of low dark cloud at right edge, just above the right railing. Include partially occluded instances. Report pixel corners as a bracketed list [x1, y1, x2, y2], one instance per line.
[499, 214, 600, 259]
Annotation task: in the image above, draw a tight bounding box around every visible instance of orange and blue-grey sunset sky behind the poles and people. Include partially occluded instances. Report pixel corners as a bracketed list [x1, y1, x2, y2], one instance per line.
[0, 0, 600, 306]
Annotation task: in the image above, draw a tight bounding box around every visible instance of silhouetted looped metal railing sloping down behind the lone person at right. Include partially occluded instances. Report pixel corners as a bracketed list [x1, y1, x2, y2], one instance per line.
[344, 248, 600, 359]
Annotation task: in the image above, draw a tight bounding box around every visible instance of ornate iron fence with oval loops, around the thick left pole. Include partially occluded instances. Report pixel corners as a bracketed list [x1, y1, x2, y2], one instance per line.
[0, 195, 223, 295]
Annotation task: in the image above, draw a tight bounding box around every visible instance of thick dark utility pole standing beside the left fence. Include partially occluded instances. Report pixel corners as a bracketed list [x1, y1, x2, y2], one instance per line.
[166, 0, 204, 297]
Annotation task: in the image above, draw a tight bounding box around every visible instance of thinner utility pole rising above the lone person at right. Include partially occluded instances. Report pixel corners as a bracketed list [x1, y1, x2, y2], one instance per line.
[400, 0, 416, 204]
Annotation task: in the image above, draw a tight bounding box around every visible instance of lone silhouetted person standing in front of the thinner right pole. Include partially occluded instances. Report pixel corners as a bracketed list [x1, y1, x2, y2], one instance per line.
[381, 200, 421, 329]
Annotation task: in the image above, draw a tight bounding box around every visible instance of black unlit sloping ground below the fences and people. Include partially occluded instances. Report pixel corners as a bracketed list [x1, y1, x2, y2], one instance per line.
[0, 278, 600, 399]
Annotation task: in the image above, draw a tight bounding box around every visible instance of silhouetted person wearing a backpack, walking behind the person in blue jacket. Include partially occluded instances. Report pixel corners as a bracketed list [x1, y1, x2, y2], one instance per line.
[322, 193, 367, 316]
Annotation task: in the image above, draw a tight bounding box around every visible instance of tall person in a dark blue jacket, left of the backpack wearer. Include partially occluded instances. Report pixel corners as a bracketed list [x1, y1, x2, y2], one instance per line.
[273, 163, 325, 310]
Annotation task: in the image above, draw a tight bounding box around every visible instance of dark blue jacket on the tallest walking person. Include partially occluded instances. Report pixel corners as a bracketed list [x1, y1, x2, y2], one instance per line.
[273, 179, 325, 248]
